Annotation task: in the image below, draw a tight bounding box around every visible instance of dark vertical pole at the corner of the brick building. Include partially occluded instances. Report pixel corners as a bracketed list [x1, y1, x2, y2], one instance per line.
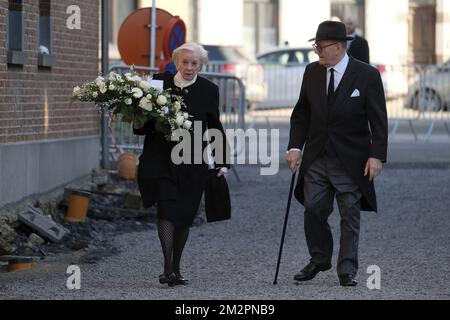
[101, 0, 109, 170]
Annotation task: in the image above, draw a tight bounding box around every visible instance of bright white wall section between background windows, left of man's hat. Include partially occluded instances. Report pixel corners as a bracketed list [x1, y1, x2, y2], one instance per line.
[279, 0, 330, 46]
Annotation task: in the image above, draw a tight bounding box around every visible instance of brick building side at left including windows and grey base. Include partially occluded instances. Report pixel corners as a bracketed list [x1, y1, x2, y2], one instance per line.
[0, 0, 100, 208]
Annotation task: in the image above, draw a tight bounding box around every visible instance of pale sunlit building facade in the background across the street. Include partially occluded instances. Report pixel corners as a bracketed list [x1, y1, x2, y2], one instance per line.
[112, 0, 450, 64]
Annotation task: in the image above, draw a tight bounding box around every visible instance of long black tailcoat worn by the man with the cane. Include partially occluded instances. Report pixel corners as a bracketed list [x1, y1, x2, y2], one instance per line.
[288, 57, 388, 211]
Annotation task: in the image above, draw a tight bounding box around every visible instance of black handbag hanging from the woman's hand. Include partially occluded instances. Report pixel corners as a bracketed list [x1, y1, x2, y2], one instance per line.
[205, 169, 231, 222]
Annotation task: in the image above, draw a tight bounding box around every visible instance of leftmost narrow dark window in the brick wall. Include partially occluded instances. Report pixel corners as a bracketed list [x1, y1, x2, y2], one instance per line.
[7, 0, 27, 65]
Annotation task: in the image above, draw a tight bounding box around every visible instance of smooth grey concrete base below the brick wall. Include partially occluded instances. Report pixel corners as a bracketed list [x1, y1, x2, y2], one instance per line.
[0, 137, 100, 207]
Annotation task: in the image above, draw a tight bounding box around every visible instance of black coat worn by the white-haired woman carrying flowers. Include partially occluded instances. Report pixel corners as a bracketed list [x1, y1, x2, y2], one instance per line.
[134, 73, 228, 219]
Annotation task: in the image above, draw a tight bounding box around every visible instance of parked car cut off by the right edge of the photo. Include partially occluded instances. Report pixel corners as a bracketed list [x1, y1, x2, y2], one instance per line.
[405, 60, 450, 111]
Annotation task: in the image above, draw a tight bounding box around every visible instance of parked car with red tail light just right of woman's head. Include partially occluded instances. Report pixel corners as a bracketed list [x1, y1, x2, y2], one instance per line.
[203, 45, 267, 108]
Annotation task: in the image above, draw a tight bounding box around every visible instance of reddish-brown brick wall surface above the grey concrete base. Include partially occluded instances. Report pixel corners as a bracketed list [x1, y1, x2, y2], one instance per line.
[0, 0, 100, 144]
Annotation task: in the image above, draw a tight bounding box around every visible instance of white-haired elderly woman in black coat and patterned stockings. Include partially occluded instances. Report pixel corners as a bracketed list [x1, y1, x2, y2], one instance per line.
[134, 43, 228, 286]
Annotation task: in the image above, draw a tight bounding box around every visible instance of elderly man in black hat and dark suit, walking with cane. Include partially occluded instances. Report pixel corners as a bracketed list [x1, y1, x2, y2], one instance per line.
[287, 21, 388, 286]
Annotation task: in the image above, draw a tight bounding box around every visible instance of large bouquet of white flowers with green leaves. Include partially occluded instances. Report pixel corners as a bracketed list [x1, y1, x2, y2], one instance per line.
[72, 72, 192, 141]
